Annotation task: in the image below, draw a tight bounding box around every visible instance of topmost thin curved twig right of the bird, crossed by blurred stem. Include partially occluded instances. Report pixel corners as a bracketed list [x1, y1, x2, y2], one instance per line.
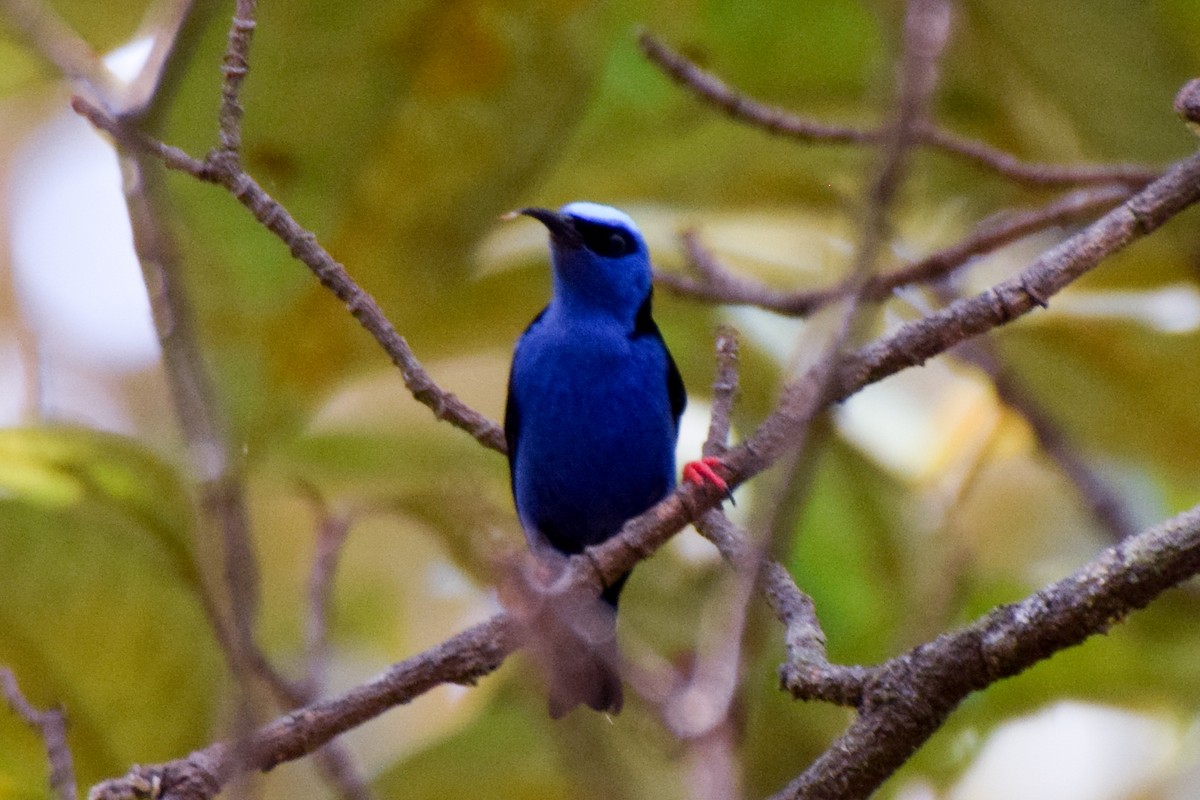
[638, 32, 1159, 187]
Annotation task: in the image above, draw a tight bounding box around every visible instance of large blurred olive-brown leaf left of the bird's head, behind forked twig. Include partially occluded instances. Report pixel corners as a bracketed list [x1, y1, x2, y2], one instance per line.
[151, 0, 624, 450]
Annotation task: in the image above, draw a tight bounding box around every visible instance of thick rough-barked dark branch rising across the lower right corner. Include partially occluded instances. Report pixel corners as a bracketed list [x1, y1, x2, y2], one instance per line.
[774, 506, 1200, 800]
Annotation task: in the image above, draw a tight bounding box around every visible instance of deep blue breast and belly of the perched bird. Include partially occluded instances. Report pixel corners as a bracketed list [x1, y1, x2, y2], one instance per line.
[506, 314, 682, 554]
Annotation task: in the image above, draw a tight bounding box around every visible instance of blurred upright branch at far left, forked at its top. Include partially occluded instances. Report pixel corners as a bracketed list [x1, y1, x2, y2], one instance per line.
[7, 0, 379, 800]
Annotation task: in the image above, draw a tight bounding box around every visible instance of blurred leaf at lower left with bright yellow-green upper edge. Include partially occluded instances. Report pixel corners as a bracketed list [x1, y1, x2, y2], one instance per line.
[0, 428, 221, 792]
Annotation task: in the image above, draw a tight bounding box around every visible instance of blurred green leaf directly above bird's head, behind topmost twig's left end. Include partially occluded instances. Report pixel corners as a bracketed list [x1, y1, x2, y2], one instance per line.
[540, 1, 886, 210]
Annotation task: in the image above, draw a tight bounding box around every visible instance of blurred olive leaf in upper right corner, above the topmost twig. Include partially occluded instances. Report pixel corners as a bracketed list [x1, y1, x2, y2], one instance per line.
[952, 0, 1196, 163]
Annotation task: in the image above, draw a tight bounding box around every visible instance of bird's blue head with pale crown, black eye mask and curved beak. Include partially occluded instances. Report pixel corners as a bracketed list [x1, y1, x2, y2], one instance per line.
[516, 203, 650, 320]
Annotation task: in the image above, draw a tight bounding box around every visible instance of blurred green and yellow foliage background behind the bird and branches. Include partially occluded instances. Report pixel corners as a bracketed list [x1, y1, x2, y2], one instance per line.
[0, 0, 1200, 800]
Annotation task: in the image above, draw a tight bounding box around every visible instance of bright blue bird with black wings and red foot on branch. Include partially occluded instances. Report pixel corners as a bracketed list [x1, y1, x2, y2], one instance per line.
[504, 201, 728, 718]
